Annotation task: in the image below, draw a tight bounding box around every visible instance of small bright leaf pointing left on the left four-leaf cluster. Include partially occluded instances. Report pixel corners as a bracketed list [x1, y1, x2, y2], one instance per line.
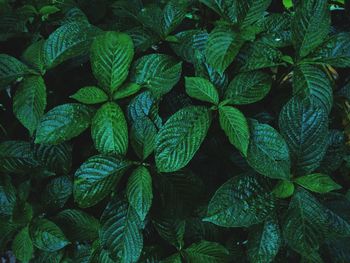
[69, 86, 108, 104]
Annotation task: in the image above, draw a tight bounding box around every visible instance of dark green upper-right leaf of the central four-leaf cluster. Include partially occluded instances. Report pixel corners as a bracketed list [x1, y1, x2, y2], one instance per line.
[225, 71, 272, 105]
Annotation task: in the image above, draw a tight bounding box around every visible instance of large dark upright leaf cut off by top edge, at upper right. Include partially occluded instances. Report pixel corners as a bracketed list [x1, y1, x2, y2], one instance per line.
[292, 0, 330, 57]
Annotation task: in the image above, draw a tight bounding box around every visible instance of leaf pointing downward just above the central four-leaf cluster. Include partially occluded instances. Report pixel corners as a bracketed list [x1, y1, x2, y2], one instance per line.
[206, 26, 244, 74]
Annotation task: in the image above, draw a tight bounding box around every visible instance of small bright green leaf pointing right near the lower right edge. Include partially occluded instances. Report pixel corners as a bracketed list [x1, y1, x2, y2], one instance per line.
[295, 173, 342, 194]
